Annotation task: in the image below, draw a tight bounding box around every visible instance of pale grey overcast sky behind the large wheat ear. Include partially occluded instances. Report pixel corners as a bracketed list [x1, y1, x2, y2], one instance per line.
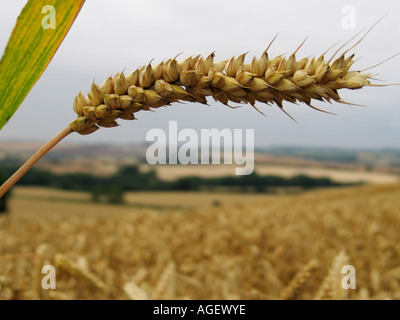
[0, 0, 400, 148]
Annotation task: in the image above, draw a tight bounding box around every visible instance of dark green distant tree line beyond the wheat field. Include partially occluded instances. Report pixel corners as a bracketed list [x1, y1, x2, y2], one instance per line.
[0, 165, 354, 206]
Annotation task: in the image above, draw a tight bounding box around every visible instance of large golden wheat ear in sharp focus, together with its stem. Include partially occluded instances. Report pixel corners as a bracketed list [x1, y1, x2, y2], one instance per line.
[0, 33, 388, 197]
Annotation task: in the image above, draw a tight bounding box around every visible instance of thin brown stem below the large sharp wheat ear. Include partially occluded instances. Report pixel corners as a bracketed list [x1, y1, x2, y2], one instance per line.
[0, 126, 73, 198]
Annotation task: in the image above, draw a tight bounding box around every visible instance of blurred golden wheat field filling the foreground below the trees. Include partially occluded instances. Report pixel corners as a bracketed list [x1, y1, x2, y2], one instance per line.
[0, 184, 400, 299]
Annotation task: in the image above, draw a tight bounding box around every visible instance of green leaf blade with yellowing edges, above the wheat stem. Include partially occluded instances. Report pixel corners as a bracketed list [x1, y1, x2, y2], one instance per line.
[0, 0, 85, 130]
